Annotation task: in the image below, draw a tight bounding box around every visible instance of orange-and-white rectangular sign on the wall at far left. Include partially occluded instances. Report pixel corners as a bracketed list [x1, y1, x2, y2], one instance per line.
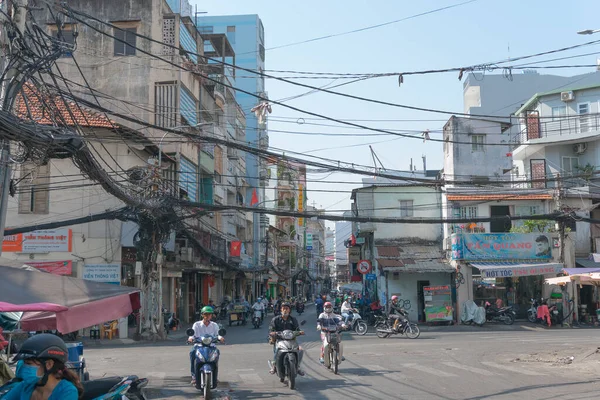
[2, 229, 73, 253]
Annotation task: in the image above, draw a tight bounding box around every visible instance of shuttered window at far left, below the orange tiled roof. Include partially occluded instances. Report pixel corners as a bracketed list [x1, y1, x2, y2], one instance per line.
[19, 163, 50, 214]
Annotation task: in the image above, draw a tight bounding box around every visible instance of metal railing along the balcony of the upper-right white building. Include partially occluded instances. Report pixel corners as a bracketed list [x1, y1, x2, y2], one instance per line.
[511, 114, 600, 149]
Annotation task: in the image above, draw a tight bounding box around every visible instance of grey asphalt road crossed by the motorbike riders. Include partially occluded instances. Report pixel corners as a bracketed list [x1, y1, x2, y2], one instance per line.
[85, 307, 600, 400]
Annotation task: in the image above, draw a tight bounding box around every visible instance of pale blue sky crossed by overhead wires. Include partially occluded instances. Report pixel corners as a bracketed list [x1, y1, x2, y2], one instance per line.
[191, 0, 600, 222]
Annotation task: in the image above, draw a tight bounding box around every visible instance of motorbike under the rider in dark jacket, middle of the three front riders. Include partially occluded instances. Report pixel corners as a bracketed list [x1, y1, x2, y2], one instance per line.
[269, 321, 306, 390]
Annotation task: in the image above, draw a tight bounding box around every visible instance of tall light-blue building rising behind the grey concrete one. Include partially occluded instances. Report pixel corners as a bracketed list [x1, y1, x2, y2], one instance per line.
[196, 15, 269, 274]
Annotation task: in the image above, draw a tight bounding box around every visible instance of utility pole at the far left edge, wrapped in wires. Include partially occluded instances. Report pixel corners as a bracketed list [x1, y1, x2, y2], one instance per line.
[0, 0, 27, 254]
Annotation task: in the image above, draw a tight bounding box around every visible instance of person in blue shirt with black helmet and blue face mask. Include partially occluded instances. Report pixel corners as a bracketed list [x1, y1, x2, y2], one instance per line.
[1, 333, 83, 400]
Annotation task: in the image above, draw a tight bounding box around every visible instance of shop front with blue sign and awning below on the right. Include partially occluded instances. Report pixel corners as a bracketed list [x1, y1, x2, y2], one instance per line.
[452, 233, 574, 318]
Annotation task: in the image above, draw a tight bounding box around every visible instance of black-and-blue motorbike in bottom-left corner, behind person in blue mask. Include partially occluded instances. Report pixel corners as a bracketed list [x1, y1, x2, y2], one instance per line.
[0, 375, 148, 400]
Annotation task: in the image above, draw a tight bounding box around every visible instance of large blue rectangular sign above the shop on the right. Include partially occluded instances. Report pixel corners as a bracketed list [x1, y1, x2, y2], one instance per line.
[452, 233, 552, 260]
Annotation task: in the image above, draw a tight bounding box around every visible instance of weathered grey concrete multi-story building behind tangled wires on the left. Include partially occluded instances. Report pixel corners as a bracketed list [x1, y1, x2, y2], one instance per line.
[18, 0, 254, 321]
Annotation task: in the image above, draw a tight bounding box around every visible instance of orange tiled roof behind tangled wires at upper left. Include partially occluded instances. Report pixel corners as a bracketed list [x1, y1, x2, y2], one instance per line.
[15, 84, 117, 129]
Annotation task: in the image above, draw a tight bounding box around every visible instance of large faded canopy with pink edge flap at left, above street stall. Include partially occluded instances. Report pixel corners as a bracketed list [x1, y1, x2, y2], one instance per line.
[0, 266, 140, 333]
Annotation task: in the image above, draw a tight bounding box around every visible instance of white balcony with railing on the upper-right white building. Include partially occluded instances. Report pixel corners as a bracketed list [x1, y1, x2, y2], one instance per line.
[510, 114, 600, 157]
